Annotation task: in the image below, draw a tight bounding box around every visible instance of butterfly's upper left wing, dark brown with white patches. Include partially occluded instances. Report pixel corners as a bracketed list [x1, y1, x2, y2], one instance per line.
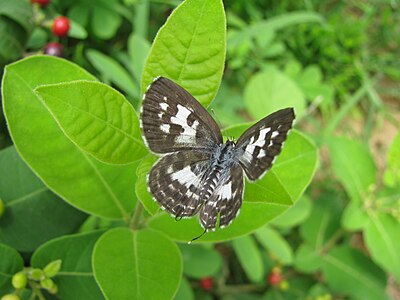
[140, 77, 222, 154]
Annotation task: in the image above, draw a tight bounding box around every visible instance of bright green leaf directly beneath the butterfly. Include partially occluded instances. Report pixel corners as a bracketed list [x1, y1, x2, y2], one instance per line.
[145, 130, 317, 242]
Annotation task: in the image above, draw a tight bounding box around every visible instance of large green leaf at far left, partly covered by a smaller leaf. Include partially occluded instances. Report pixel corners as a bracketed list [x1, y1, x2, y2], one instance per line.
[2, 56, 136, 219]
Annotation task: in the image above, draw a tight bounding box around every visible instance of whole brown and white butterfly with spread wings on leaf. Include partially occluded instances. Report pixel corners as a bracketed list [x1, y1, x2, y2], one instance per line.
[140, 77, 295, 232]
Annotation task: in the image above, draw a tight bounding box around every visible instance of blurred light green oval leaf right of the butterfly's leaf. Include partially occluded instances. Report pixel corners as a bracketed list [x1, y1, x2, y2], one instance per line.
[328, 136, 376, 202]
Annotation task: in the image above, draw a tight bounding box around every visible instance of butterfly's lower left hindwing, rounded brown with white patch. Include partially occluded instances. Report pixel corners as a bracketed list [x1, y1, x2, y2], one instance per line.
[147, 150, 210, 217]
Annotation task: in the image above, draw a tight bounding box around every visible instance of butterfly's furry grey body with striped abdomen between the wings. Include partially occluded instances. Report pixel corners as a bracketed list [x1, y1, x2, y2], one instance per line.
[200, 140, 236, 201]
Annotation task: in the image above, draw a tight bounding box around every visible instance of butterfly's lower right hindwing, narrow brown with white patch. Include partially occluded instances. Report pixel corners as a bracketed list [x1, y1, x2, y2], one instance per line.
[200, 164, 244, 230]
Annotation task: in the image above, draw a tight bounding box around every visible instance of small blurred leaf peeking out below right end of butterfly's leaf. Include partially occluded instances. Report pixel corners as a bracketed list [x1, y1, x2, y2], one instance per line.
[271, 195, 311, 229]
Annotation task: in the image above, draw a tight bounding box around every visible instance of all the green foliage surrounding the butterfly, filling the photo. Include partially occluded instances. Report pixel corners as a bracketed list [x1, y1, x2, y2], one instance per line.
[0, 0, 400, 300]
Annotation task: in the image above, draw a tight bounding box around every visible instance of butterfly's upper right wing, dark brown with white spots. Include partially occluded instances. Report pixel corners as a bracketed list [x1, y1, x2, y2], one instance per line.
[236, 108, 295, 181]
